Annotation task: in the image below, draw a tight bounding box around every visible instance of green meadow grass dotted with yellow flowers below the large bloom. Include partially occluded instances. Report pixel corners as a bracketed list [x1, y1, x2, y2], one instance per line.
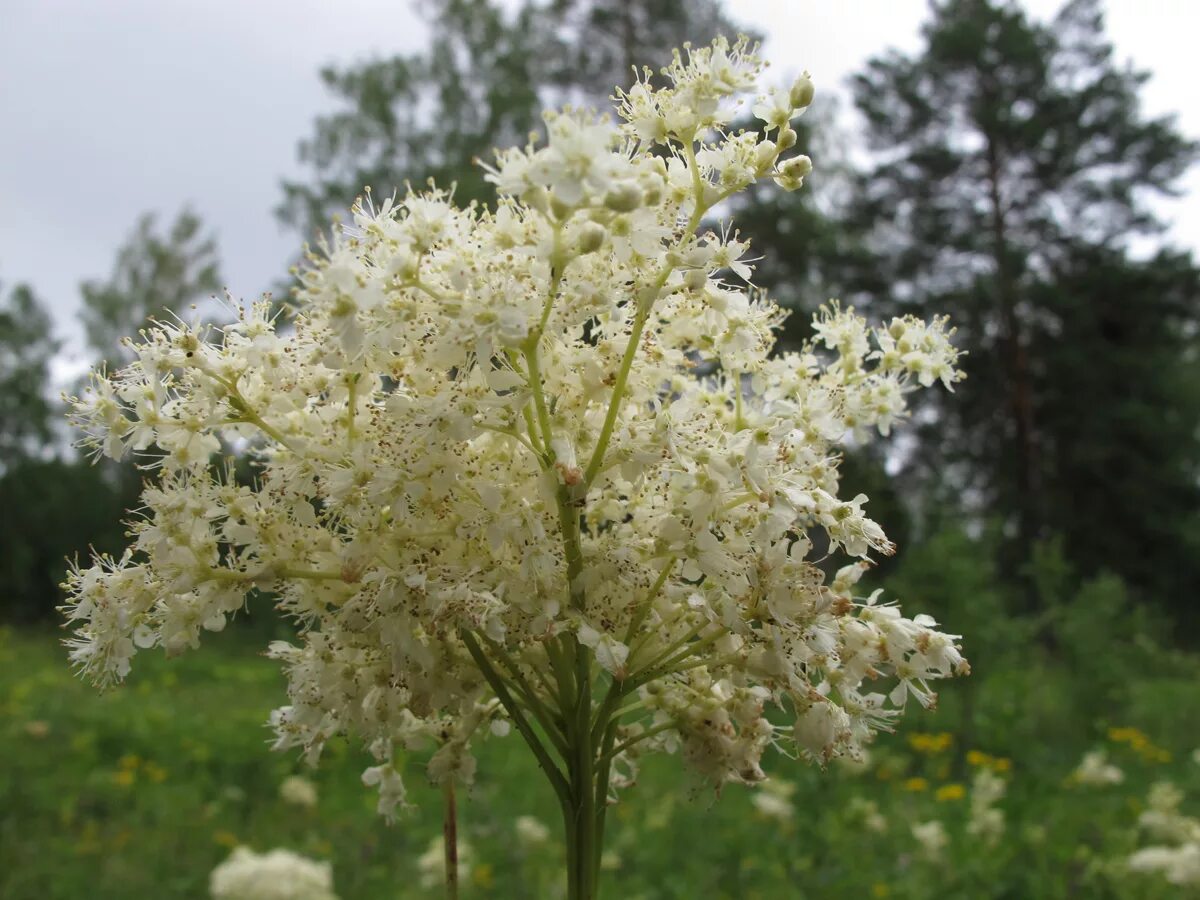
[0, 630, 1200, 900]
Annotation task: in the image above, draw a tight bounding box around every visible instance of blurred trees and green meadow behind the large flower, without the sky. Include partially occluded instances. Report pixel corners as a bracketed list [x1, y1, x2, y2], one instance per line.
[0, 0, 1200, 899]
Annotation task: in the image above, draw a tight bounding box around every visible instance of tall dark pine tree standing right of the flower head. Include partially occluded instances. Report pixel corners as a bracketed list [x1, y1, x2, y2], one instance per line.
[854, 0, 1196, 614]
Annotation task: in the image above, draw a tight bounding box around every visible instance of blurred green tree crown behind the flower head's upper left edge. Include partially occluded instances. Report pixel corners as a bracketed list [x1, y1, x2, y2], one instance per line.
[277, 0, 737, 236]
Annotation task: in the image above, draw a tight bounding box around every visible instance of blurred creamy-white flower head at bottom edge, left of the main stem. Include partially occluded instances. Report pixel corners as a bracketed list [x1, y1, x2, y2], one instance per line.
[209, 847, 337, 900]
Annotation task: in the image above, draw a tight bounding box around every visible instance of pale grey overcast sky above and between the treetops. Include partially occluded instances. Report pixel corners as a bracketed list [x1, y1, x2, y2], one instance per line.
[0, 0, 1200, 374]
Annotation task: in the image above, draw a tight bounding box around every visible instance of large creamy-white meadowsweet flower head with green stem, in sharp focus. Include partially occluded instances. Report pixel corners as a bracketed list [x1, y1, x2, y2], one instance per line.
[66, 40, 966, 899]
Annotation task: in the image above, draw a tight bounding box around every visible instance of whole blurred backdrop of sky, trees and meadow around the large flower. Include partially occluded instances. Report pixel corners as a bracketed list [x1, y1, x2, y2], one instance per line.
[0, 0, 1200, 900]
